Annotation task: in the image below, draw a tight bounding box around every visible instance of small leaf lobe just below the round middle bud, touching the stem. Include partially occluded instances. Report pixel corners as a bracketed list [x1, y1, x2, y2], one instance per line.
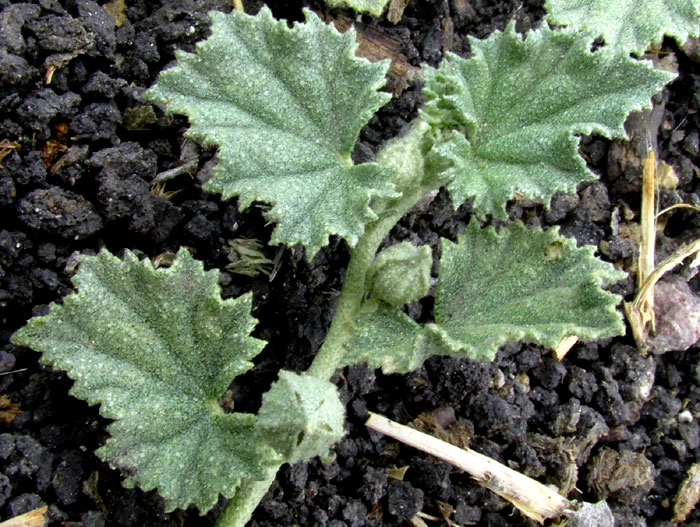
[341, 302, 431, 373]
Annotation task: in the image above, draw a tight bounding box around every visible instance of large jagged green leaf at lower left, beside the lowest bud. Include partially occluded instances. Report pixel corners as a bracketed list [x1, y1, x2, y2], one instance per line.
[12, 249, 277, 513]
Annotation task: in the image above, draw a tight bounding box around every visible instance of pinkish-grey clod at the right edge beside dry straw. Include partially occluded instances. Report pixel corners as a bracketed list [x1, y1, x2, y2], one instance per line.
[649, 278, 700, 353]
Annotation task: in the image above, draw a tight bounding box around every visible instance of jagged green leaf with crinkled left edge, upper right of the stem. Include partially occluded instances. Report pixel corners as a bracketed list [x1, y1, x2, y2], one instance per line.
[423, 24, 673, 219]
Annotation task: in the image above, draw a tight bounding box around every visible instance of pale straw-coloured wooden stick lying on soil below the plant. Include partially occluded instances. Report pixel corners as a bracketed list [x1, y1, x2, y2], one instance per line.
[365, 412, 574, 523]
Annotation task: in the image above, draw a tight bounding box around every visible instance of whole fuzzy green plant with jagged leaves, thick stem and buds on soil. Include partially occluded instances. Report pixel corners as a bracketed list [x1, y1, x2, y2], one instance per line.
[13, 0, 700, 527]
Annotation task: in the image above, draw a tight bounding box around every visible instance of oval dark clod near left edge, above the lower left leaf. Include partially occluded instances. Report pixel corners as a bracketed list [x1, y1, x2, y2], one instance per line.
[17, 187, 102, 240]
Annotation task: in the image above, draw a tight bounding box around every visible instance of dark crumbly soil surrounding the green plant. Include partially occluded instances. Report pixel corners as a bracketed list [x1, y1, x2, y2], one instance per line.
[0, 0, 700, 527]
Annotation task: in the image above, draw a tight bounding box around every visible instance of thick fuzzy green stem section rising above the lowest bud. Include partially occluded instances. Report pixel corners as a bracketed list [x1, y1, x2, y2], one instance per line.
[306, 186, 433, 379]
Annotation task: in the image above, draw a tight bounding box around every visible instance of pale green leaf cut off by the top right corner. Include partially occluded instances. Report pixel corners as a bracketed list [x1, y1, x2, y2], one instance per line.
[545, 0, 700, 56]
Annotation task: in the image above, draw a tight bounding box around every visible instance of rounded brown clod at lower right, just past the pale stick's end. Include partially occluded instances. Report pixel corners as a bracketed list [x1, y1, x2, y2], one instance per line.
[587, 447, 656, 506]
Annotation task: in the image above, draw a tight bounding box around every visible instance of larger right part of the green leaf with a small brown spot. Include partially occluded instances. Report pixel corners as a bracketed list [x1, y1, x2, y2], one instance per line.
[428, 221, 625, 360]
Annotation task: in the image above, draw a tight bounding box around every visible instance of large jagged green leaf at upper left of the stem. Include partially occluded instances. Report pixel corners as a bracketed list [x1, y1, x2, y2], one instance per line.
[147, 7, 395, 258]
